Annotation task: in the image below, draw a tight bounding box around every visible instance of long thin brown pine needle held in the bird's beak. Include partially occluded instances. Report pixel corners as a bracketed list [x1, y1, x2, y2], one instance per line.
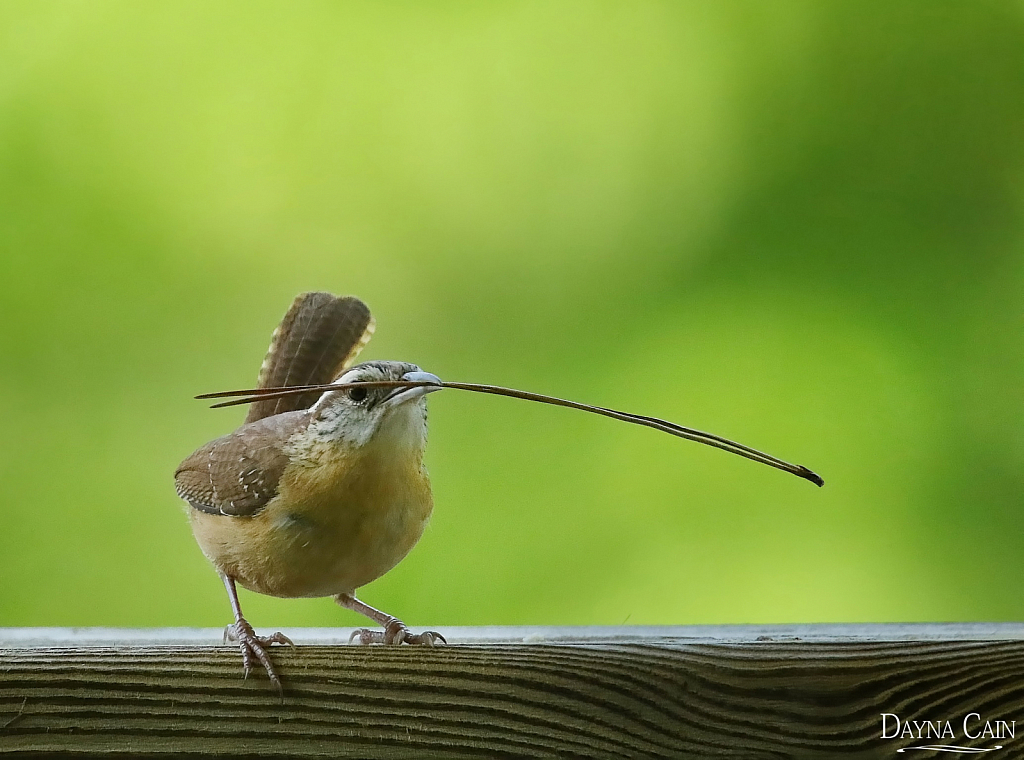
[196, 380, 824, 485]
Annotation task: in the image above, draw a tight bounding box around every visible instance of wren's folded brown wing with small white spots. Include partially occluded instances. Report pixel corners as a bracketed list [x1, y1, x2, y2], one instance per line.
[174, 411, 308, 515]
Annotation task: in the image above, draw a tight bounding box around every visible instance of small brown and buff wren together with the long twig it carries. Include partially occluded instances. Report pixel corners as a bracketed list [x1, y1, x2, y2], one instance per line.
[174, 293, 823, 692]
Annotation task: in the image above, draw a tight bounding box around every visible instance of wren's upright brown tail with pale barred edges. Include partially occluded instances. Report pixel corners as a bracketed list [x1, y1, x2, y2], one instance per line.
[246, 293, 374, 422]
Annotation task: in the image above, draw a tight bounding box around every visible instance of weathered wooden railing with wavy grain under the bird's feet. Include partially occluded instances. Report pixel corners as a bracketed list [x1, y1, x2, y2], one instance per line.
[0, 624, 1024, 758]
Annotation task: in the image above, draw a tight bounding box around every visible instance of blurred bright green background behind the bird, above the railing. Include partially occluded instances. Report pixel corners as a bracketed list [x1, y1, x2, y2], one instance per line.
[0, 0, 1024, 628]
